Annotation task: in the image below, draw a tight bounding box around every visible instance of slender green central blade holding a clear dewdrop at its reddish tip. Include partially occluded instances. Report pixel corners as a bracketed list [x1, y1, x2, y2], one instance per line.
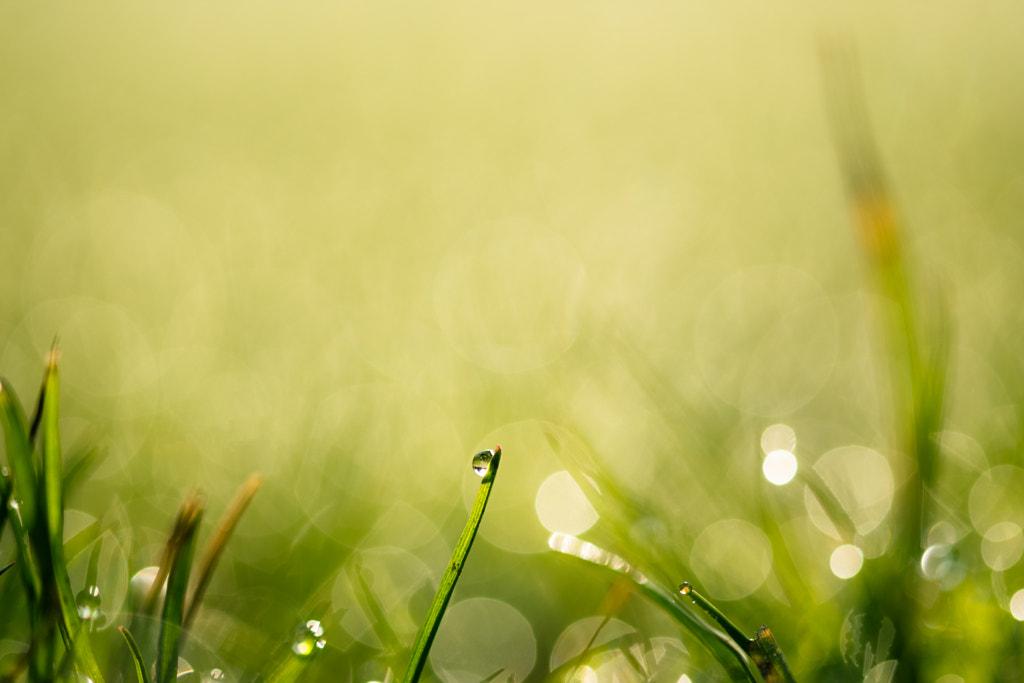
[403, 445, 502, 683]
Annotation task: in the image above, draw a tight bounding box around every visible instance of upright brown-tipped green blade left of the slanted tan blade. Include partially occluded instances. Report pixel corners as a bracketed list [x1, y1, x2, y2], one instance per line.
[157, 495, 204, 683]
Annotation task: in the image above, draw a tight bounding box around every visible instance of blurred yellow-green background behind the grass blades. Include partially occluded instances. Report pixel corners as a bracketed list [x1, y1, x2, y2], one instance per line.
[0, 0, 1024, 683]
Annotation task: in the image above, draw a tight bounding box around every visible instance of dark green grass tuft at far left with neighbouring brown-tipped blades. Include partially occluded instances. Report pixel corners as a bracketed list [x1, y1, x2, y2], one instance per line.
[0, 352, 260, 683]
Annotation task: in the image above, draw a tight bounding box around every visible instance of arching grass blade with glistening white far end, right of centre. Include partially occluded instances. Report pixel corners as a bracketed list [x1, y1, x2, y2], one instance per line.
[548, 533, 757, 683]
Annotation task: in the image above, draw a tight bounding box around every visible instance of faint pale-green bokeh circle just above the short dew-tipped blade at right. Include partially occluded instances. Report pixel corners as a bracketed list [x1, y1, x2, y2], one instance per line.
[690, 519, 772, 600]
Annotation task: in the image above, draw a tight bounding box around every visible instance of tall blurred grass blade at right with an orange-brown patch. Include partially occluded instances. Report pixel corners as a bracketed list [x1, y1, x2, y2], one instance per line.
[821, 42, 950, 680]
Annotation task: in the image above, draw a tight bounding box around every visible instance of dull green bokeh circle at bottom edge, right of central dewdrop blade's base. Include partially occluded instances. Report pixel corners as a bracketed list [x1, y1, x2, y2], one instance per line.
[430, 598, 537, 683]
